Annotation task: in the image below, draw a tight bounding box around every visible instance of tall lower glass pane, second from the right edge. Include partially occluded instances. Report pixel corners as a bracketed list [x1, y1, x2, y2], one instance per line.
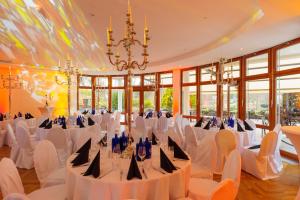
[246, 79, 269, 126]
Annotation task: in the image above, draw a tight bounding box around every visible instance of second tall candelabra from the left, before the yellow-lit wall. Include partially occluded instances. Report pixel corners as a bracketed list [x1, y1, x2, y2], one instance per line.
[55, 59, 80, 116]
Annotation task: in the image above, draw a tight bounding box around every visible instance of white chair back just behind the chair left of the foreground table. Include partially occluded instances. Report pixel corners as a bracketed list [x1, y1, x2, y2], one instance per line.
[46, 127, 68, 149]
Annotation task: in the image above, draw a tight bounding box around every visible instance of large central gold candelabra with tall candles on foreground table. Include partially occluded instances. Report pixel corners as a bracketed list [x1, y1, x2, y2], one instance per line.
[107, 1, 150, 133]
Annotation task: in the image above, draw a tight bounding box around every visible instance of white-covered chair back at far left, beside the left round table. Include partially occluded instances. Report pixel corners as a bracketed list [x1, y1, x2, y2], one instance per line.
[16, 123, 33, 149]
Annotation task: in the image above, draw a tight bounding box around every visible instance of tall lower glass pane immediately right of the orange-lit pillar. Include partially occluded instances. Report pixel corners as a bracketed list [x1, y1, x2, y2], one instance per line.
[181, 86, 197, 116]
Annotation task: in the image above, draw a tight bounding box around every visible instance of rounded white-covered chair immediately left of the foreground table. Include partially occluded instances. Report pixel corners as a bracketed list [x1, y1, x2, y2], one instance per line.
[33, 140, 65, 188]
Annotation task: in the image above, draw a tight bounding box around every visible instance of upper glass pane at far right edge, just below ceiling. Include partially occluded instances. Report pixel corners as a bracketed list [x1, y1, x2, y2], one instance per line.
[277, 44, 300, 71]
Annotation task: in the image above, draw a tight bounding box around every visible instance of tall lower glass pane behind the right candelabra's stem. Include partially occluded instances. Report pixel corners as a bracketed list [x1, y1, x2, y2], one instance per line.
[223, 85, 238, 118]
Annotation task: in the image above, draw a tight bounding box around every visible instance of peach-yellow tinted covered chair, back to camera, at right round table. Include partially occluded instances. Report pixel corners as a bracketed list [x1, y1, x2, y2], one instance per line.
[215, 129, 237, 173]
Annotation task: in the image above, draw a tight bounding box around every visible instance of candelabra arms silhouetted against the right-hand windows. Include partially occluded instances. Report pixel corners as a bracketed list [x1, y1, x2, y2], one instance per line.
[210, 58, 237, 86]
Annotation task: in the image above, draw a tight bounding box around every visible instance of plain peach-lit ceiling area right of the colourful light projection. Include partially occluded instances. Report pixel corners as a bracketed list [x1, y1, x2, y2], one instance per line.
[76, 0, 300, 73]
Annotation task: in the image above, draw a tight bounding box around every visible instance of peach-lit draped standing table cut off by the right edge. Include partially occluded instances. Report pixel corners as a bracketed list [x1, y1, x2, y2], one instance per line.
[281, 126, 300, 199]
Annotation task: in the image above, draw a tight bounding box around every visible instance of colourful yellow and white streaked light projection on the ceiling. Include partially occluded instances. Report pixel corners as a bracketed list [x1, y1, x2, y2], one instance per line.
[0, 0, 105, 69]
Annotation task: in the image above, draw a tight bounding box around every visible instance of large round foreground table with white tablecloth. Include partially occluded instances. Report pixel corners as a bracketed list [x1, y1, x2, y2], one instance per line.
[66, 146, 191, 200]
